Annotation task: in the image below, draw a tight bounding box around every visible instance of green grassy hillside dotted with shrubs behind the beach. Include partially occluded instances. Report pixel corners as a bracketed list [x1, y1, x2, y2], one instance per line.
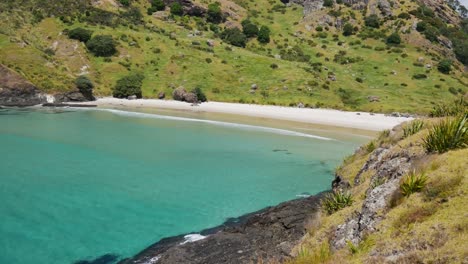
[0, 0, 468, 113]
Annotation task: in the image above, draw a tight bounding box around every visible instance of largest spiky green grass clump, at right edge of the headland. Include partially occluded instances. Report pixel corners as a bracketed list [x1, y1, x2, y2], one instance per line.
[423, 114, 468, 153]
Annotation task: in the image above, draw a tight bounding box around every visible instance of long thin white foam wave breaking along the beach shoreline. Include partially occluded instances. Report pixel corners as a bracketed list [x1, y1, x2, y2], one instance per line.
[80, 108, 333, 140]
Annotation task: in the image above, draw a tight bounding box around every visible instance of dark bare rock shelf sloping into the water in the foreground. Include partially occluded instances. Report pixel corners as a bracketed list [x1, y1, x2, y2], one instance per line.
[120, 195, 321, 264]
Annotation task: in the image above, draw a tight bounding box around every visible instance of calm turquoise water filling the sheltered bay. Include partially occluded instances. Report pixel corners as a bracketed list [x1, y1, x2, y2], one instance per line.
[0, 109, 357, 264]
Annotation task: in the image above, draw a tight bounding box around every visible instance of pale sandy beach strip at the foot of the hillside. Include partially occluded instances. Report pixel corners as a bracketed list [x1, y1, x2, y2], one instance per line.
[78, 97, 411, 131]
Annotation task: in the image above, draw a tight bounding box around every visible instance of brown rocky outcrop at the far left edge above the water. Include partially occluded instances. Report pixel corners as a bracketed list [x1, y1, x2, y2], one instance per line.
[0, 64, 47, 106]
